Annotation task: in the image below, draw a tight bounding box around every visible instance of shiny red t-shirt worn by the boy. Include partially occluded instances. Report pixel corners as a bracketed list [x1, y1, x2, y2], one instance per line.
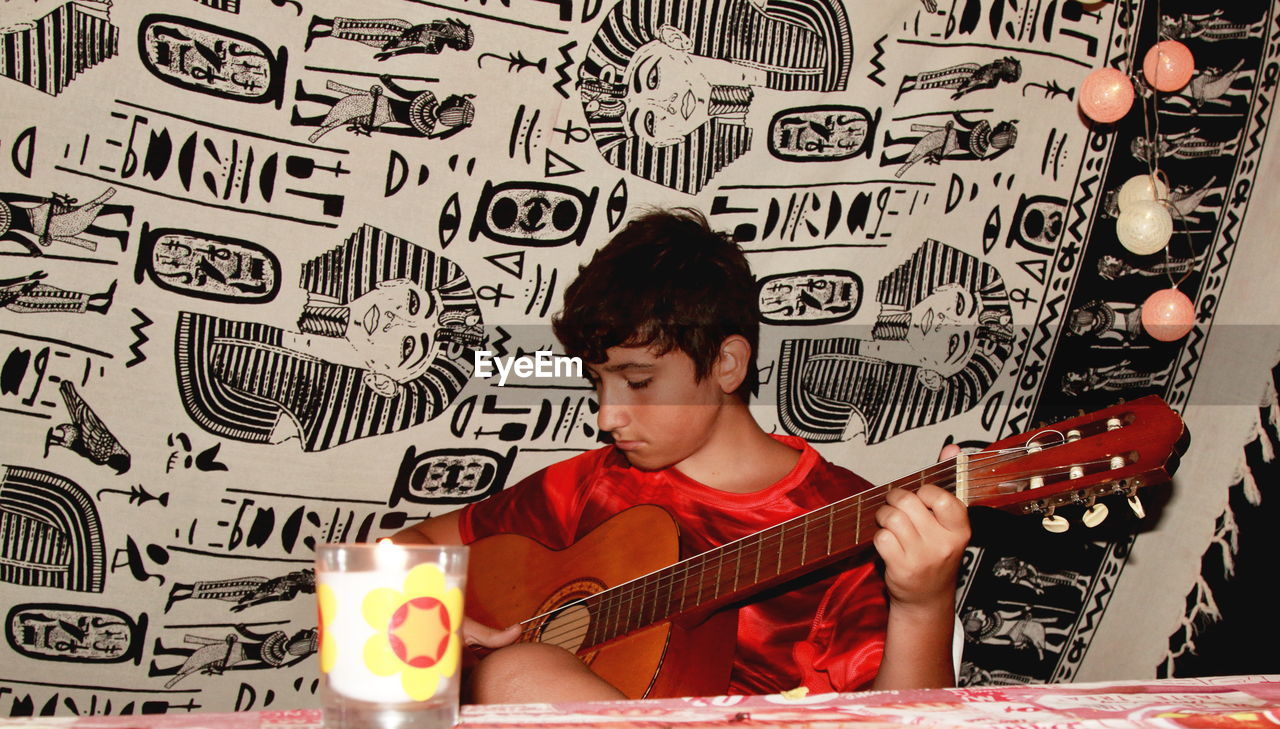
[458, 435, 888, 693]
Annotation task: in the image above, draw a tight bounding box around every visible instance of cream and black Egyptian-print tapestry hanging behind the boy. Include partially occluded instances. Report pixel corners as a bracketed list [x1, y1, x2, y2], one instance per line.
[0, 0, 1280, 715]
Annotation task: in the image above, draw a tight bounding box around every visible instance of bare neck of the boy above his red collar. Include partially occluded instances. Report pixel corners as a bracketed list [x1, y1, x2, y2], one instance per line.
[672, 395, 800, 494]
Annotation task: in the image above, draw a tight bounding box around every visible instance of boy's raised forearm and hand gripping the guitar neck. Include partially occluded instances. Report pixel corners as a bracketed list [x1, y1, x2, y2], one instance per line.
[872, 442, 969, 689]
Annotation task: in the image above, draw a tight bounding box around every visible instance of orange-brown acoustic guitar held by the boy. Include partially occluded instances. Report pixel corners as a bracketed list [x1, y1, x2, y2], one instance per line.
[466, 395, 1189, 698]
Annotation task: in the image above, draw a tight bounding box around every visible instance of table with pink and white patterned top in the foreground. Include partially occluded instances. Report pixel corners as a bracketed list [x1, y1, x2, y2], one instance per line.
[0, 675, 1280, 729]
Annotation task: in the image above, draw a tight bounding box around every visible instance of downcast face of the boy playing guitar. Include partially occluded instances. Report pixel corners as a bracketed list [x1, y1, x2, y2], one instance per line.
[586, 347, 733, 471]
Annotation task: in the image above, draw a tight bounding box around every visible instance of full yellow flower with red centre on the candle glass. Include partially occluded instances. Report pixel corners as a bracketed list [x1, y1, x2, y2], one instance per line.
[361, 564, 462, 701]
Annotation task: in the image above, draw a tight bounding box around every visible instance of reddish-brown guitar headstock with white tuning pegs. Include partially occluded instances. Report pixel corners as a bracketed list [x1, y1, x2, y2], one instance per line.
[955, 395, 1190, 521]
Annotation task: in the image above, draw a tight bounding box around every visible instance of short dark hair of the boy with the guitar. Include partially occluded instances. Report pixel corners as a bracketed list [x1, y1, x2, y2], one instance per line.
[552, 208, 760, 400]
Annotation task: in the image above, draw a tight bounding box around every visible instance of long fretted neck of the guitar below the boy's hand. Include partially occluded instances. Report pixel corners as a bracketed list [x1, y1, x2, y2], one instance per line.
[582, 469, 926, 648]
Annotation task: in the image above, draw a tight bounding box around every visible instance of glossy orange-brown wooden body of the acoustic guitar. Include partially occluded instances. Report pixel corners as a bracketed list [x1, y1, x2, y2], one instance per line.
[466, 505, 737, 698]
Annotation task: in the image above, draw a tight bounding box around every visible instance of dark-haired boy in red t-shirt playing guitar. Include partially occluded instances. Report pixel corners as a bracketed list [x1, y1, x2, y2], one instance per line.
[396, 210, 969, 703]
